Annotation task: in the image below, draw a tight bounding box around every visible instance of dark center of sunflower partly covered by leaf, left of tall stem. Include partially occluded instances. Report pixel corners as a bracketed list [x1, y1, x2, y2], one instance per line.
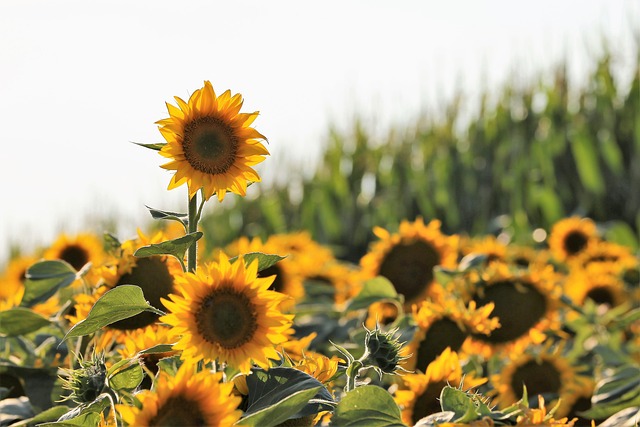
[110, 256, 173, 330]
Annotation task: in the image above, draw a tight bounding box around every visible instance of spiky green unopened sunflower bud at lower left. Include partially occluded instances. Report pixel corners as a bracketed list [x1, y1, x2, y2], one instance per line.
[62, 355, 107, 403]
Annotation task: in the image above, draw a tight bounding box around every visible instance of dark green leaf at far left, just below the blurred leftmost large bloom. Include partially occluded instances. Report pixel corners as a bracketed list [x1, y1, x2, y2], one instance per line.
[20, 260, 77, 307]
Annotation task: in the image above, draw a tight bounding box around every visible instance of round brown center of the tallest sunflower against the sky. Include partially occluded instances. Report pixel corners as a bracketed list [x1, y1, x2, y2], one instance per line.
[182, 116, 238, 175]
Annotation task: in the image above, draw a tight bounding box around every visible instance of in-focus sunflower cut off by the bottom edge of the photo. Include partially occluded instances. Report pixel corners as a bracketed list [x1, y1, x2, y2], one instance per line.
[116, 363, 242, 426]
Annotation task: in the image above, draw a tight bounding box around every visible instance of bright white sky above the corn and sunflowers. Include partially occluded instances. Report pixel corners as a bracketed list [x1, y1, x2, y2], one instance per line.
[0, 0, 640, 266]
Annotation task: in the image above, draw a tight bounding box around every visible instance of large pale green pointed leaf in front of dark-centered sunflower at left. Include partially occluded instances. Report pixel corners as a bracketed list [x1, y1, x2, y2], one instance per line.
[63, 285, 164, 340]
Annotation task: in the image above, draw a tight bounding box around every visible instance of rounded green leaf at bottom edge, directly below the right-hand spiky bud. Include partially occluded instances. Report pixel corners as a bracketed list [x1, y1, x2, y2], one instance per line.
[329, 385, 405, 427]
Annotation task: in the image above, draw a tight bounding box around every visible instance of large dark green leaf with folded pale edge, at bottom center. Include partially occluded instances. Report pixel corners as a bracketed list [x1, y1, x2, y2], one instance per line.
[242, 367, 333, 426]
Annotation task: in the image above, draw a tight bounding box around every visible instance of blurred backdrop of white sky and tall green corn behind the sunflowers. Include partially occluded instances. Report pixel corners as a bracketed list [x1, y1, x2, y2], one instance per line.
[0, 0, 640, 265]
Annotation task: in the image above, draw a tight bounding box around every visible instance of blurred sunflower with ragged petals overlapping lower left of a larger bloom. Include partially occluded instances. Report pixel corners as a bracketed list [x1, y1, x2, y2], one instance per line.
[404, 298, 500, 370]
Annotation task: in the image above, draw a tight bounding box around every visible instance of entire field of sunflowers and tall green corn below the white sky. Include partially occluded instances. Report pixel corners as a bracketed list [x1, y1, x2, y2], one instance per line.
[0, 44, 640, 427]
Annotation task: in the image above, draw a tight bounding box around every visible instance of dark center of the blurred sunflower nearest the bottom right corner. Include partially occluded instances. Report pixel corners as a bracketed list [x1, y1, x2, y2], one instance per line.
[511, 360, 562, 405]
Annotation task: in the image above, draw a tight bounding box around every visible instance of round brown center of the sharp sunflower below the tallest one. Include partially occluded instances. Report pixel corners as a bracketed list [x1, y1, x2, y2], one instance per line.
[195, 288, 258, 349]
